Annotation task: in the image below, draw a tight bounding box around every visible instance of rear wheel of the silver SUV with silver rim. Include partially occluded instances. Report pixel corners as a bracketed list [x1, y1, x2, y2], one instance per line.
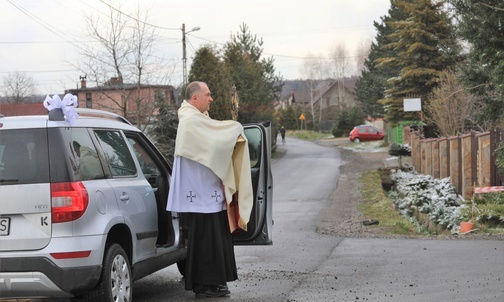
[83, 243, 133, 302]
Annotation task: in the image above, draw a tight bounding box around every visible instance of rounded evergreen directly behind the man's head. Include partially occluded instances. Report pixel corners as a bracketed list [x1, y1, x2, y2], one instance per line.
[189, 45, 232, 120]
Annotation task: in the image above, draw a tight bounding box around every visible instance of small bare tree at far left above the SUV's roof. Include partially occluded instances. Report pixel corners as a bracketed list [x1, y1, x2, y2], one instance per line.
[2, 72, 36, 104]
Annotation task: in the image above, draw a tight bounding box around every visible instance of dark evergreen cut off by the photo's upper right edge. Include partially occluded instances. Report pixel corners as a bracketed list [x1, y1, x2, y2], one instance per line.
[450, 0, 504, 127]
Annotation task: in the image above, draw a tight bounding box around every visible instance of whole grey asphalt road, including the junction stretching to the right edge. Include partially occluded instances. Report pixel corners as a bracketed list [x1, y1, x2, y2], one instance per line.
[8, 137, 504, 302]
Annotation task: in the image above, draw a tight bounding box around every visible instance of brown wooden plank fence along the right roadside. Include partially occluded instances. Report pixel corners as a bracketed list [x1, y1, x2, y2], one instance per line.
[403, 127, 504, 199]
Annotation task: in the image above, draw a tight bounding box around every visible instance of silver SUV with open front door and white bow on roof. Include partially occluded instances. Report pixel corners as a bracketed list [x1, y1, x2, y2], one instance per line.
[0, 109, 273, 301]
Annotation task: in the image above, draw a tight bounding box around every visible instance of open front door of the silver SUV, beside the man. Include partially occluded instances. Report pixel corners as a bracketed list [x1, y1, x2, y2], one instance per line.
[233, 122, 273, 245]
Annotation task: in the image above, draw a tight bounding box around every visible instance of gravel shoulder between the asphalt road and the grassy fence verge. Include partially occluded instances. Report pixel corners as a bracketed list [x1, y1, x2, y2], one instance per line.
[317, 138, 504, 240]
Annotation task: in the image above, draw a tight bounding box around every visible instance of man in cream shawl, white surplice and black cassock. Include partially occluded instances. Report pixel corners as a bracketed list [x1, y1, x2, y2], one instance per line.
[167, 82, 253, 297]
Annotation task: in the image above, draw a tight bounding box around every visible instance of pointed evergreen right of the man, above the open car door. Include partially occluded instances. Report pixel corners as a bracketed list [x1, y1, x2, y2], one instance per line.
[223, 24, 283, 123]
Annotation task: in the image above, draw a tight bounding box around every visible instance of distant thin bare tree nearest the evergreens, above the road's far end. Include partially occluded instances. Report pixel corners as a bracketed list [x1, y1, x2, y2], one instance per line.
[300, 53, 329, 129]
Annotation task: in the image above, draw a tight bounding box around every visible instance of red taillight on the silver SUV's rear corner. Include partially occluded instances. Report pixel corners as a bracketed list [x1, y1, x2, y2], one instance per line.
[51, 182, 89, 223]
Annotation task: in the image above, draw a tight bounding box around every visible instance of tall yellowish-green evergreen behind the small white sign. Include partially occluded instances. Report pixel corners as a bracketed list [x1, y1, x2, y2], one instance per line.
[377, 0, 460, 125]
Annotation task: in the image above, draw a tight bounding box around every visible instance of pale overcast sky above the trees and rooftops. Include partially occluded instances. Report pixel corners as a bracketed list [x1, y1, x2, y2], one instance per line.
[0, 0, 390, 94]
